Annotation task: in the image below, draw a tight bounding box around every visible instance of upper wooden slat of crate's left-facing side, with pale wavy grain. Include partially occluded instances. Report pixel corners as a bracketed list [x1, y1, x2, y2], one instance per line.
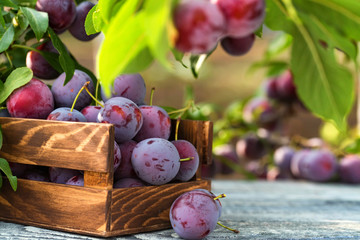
[0, 117, 114, 172]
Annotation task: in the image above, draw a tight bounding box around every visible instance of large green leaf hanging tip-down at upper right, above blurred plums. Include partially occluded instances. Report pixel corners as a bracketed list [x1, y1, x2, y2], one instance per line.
[291, 28, 354, 131]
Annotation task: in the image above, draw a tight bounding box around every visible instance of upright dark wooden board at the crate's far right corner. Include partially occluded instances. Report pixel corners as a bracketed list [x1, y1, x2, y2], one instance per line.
[170, 119, 213, 164]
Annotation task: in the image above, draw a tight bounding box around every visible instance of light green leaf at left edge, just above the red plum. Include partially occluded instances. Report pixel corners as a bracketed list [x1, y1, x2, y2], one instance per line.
[0, 67, 33, 103]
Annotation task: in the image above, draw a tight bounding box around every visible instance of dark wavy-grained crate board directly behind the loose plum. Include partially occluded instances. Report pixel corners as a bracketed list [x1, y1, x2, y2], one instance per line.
[109, 180, 210, 236]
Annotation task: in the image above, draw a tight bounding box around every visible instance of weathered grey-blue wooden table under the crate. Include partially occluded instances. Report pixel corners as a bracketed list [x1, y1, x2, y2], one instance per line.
[0, 180, 360, 240]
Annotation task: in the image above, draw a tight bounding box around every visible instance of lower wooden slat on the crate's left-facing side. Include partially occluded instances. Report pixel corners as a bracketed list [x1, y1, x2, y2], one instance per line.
[0, 179, 111, 236]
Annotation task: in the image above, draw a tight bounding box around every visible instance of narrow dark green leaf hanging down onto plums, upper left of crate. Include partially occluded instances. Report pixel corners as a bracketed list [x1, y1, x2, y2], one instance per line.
[48, 28, 75, 84]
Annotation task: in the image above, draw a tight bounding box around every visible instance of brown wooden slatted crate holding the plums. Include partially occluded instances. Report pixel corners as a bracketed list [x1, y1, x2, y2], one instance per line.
[0, 118, 212, 237]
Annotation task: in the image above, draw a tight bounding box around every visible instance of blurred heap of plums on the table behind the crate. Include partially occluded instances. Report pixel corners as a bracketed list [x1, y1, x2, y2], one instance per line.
[210, 70, 360, 183]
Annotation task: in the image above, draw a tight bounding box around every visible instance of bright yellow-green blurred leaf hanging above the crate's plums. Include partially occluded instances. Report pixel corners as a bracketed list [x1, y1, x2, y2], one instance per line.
[97, 1, 146, 93]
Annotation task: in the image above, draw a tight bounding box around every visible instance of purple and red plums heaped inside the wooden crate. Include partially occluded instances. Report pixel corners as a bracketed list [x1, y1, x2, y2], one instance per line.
[6, 70, 199, 188]
